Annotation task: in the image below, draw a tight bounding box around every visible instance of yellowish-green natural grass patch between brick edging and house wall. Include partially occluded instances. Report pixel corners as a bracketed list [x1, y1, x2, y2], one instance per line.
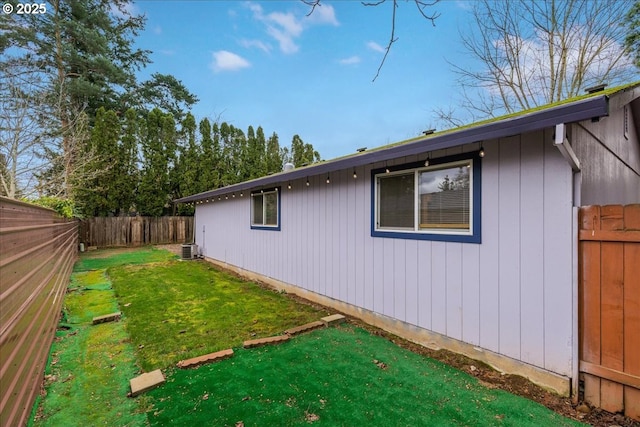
[109, 261, 328, 371]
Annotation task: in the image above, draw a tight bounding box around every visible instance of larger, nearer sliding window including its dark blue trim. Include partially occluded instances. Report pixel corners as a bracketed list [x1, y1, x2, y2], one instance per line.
[372, 155, 480, 243]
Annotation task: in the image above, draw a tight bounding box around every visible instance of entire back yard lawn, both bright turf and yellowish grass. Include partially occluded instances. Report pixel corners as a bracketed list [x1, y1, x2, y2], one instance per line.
[31, 249, 616, 426]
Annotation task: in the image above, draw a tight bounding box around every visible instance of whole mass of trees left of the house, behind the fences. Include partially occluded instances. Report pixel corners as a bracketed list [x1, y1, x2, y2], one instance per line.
[0, 0, 320, 216]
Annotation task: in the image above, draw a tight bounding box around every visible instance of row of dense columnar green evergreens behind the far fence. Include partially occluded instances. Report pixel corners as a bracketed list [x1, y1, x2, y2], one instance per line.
[76, 107, 320, 216]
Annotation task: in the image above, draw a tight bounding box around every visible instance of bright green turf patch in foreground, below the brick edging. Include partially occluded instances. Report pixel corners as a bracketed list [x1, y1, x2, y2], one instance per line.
[148, 325, 580, 427]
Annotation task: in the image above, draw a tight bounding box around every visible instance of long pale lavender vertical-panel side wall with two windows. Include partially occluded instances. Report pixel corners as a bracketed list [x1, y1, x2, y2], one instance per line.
[195, 130, 574, 377]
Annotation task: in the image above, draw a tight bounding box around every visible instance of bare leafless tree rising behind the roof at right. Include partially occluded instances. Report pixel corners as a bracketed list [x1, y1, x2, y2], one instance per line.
[436, 0, 637, 123]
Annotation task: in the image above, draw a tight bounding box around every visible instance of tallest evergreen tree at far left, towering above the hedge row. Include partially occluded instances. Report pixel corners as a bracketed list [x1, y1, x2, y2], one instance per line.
[0, 0, 197, 202]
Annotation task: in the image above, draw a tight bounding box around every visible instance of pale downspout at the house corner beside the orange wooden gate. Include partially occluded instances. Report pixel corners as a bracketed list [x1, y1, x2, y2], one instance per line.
[553, 123, 582, 404]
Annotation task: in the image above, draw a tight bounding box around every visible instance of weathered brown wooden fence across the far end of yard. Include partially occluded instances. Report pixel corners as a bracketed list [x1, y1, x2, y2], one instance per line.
[80, 216, 193, 248]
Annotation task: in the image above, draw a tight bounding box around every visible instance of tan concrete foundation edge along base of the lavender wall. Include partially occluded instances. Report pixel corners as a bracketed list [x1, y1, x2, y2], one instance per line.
[204, 257, 571, 396]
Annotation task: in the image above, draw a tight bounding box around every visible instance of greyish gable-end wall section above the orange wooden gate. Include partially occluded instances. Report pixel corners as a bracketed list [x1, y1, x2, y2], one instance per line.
[571, 100, 640, 206]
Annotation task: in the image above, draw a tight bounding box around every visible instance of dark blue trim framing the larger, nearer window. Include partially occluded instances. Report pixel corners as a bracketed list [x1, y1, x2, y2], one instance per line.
[371, 151, 482, 243]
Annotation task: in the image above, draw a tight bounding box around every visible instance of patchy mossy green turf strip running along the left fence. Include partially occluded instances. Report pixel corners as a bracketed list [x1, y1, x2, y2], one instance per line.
[31, 270, 146, 426]
